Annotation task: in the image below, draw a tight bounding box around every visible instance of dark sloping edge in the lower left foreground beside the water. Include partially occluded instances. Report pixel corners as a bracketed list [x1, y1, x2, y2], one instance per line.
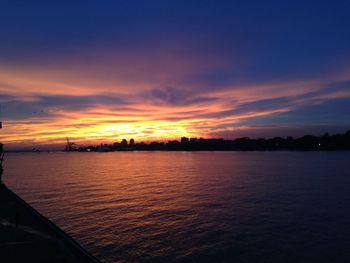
[0, 183, 99, 263]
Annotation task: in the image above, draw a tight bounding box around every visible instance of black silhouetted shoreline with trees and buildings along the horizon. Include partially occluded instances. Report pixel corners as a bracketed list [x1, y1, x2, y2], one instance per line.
[69, 130, 350, 152]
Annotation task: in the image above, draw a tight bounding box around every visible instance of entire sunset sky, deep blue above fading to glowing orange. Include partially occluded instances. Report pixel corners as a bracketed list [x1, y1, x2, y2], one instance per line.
[0, 0, 350, 148]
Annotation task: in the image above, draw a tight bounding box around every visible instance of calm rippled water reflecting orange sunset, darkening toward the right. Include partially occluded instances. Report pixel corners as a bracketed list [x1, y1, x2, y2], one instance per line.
[4, 152, 350, 263]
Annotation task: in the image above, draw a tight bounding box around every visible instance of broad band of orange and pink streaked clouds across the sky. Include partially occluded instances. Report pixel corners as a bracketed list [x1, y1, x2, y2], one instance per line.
[0, 54, 350, 150]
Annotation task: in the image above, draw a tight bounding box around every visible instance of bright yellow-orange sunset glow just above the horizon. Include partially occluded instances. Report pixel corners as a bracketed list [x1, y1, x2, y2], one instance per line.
[3, 115, 199, 147]
